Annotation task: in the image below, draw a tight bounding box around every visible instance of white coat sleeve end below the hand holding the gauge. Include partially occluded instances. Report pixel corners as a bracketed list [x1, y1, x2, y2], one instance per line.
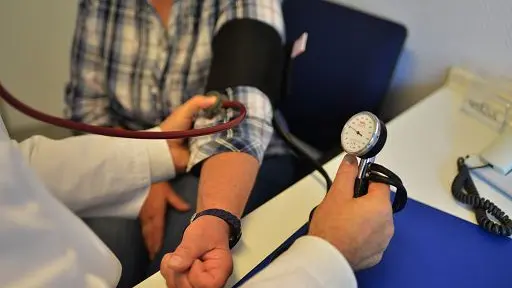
[242, 236, 357, 288]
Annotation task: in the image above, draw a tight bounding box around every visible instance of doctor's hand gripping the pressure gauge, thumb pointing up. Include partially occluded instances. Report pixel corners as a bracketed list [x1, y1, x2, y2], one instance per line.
[309, 156, 394, 270]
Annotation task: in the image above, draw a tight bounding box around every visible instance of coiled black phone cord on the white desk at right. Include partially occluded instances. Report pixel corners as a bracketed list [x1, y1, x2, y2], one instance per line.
[452, 157, 512, 237]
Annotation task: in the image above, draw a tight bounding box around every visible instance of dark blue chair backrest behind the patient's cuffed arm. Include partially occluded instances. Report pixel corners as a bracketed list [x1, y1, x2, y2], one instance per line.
[278, 0, 407, 151]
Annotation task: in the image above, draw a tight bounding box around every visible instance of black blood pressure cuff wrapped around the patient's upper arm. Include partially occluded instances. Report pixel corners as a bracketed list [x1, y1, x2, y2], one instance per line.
[206, 19, 287, 107]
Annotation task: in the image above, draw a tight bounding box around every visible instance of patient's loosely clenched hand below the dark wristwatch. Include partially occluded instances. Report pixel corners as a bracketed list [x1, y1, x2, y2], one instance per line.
[160, 216, 233, 288]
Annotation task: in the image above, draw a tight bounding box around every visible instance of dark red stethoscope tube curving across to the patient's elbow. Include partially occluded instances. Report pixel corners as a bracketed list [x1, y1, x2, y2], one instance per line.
[0, 83, 247, 139]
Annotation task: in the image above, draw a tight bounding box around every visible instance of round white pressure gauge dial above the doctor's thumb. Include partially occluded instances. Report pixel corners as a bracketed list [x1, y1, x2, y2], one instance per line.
[341, 112, 381, 156]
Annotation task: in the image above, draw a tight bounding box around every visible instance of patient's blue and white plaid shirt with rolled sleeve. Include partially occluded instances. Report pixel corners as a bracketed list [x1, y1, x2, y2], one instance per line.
[66, 0, 286, 168]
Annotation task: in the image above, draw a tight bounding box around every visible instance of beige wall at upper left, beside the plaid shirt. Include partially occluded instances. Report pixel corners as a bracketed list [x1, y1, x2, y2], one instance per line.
[0, 0, 77, 130]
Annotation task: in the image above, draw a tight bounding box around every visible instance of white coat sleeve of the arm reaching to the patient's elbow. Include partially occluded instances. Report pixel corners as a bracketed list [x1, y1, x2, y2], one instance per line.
[15, 129, 175, 218]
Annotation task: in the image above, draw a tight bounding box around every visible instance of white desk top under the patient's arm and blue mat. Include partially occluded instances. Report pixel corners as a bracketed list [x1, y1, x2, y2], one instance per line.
[137, 87, 512, 288]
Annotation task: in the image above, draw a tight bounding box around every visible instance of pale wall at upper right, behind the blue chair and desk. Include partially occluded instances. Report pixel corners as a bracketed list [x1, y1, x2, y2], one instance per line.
[330, 0, 512, 118]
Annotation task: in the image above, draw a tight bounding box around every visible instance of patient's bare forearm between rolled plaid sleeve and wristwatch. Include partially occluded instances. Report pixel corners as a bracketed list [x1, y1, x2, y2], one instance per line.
[197, 152, 259, 217]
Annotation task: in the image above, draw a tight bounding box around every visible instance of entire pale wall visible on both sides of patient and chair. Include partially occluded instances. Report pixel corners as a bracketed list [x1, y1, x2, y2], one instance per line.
[0, 0, 512, 129]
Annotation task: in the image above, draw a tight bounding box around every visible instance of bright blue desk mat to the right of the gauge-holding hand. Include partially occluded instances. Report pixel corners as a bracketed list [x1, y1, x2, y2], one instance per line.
[357, 200, 512, 288]
